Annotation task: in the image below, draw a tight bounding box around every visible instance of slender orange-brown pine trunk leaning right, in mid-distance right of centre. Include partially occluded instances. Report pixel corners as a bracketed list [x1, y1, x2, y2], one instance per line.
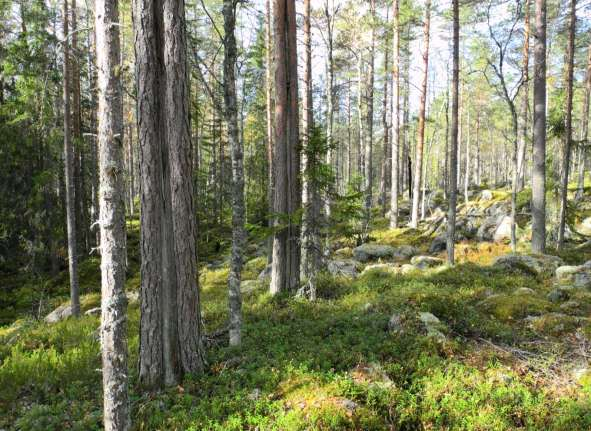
[410, 0, 431, 229]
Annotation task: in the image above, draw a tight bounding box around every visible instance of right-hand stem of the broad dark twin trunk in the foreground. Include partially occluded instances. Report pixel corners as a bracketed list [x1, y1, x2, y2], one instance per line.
[164, 0, 203, 373]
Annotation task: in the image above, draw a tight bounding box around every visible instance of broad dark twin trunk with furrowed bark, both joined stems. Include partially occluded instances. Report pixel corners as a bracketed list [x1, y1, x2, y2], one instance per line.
[134, 0, 203, 388]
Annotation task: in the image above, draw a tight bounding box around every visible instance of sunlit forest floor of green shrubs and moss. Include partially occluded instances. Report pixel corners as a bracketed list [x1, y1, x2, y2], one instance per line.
[0, 187, 591, 431]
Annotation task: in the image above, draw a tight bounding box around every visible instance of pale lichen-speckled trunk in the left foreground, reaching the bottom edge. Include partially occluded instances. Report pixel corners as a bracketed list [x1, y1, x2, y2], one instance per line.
[95, 0, 130, 431]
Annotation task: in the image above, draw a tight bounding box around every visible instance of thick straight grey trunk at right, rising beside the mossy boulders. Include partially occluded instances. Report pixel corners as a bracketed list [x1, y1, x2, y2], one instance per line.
[531, 0, 546, 253]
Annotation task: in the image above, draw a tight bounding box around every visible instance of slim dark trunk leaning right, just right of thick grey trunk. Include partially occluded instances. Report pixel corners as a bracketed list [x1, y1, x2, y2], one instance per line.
[557, 0, 577, 249]
